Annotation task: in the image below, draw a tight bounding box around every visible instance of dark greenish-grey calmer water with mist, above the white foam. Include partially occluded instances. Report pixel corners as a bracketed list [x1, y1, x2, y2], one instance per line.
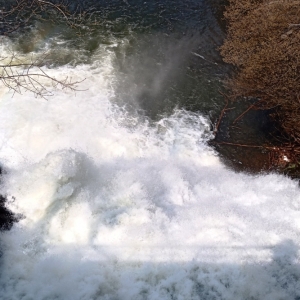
[10, 0, 229, 120]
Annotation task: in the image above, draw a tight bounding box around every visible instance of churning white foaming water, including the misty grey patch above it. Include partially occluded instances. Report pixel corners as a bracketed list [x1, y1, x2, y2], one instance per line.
[0, 0, 300, 300]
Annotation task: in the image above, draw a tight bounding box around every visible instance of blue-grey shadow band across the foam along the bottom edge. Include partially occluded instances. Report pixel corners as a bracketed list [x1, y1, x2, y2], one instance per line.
[0, 240, 300, 300]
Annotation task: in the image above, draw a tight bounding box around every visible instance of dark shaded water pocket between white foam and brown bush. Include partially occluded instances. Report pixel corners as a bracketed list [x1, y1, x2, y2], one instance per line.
[210, 99, 278, 173]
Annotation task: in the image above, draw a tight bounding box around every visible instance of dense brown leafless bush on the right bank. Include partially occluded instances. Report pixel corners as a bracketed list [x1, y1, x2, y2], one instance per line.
[221, 0, 300, 172]
